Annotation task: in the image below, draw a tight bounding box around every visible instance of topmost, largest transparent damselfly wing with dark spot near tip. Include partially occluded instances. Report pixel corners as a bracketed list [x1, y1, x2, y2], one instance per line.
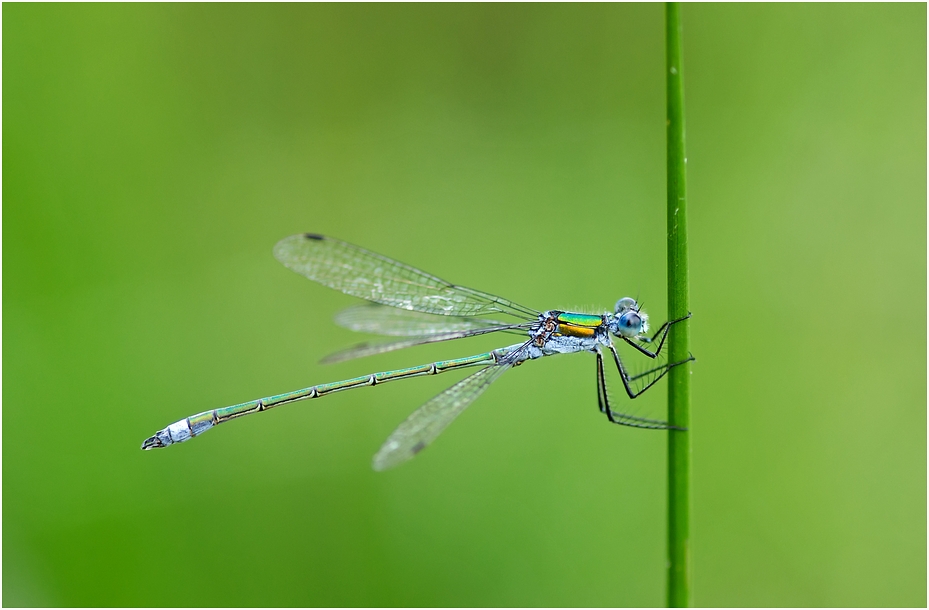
[274, 233, 539, 319]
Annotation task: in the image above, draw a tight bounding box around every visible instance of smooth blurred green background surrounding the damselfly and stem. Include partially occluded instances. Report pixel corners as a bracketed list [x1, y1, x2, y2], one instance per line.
[3, 4, 926, 606]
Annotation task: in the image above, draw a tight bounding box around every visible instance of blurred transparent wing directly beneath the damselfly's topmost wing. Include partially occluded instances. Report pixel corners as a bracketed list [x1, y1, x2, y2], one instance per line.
[335, 303, 509, 337]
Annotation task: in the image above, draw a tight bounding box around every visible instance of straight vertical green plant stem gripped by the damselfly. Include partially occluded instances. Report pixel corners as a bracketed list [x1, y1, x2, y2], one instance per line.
[665, 2, 692, 608]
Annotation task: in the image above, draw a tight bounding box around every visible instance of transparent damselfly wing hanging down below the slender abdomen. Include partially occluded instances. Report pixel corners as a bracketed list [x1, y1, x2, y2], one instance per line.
[373, 363, 512, 471]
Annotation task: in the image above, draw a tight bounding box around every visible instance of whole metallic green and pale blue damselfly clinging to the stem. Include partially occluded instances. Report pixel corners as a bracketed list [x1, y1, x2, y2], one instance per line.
[142, 233, 693, 470]
